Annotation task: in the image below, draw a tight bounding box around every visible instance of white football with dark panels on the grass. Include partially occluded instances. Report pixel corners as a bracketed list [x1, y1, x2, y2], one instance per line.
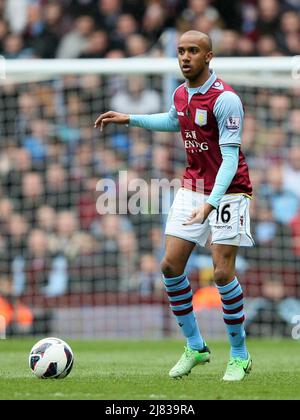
[29, 337, 74, 379]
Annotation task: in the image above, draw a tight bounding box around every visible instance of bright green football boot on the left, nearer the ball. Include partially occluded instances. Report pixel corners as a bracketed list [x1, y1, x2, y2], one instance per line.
[169, 345, 210, 379]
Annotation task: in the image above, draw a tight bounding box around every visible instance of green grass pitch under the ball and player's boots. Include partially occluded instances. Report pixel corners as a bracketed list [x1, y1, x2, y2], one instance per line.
[0, 338, 300, 400]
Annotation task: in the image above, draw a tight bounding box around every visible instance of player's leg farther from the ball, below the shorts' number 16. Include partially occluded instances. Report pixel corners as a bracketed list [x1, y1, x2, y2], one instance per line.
[212, 243, 252, 381]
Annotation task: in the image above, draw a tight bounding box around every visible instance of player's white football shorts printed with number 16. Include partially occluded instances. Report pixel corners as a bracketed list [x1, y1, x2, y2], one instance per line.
[165, 188, 254, 247]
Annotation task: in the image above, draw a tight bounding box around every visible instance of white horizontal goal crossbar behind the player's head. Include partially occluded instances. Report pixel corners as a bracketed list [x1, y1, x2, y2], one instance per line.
[2, 57, 300, 76]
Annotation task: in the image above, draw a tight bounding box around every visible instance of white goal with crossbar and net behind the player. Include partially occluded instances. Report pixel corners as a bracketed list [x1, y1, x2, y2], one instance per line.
[0, 57, 300, 338]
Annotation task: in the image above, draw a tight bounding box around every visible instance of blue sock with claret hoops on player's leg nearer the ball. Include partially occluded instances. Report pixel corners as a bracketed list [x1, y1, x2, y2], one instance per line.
[164, 274, 205, 350]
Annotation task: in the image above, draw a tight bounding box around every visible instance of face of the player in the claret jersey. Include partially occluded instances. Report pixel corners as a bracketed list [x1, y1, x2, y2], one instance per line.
[178, 39, 211, 81]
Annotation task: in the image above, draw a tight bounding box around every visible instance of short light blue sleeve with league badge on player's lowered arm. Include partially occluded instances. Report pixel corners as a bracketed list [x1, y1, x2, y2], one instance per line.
[213, 91, 244, 146]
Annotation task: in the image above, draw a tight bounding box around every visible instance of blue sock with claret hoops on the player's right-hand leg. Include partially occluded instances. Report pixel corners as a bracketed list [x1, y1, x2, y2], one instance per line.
[217, 277, 248, 359]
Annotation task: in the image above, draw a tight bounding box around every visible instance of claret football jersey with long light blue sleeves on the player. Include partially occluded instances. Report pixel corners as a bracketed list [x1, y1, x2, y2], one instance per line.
[130, 71, 252, 207]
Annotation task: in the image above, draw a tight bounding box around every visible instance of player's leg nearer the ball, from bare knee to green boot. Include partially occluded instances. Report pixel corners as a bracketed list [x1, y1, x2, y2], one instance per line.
[161, 235, 210, 378]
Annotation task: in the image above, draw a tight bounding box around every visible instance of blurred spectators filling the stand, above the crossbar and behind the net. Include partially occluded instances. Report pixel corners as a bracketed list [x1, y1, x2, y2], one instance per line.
[0, 0, 300, 308]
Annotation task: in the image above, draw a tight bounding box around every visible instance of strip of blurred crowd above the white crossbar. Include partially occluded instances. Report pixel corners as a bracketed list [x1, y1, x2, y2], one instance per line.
[0, 0, 300, 58]
